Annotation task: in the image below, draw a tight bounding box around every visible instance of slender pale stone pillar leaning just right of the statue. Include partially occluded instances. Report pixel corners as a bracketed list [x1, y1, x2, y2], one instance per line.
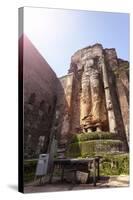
[100, 57, 116, 133]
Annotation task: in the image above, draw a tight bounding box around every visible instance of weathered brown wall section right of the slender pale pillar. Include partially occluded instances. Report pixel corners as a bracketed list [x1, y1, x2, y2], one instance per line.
[104, 49, 129, 148]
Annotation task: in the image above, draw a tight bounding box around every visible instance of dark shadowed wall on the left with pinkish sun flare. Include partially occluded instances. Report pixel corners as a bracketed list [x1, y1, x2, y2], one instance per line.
[23, 36, 58, 157]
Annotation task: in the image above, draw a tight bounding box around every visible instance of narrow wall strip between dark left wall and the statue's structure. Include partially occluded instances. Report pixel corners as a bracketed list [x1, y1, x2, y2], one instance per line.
[56, 73, 74, 144]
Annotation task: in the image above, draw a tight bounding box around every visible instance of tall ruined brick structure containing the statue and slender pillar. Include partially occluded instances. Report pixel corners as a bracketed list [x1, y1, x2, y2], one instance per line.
[58, 44, 129, 150]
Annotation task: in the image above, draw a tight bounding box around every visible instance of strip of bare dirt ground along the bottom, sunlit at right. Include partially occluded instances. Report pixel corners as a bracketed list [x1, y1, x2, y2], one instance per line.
[24, 175, 129, 193]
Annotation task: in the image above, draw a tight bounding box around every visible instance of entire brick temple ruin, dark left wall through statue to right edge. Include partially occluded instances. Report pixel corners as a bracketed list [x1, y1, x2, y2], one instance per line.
[20, 36, 129, 158]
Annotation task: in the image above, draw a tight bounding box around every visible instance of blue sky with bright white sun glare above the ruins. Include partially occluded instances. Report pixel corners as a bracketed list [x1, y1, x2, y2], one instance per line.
[24, 7, 129, 77]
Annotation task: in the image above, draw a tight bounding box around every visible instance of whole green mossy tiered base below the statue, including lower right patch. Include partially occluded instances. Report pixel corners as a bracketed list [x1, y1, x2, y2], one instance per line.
[66, 132, 129, 176]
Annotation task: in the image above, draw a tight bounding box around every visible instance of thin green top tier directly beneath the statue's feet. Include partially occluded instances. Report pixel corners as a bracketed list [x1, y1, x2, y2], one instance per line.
[71, 132, 118, 143]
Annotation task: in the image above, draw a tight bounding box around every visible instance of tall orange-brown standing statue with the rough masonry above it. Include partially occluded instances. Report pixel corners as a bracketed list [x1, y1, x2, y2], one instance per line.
[69, 44, 108, 132]
